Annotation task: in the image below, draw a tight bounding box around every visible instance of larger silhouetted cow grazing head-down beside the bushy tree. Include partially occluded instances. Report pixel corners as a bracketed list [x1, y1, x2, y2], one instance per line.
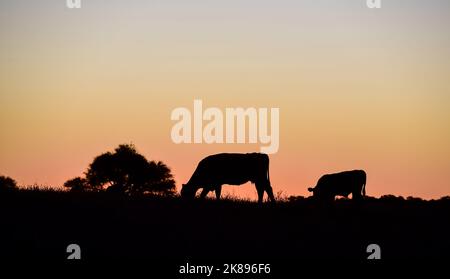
[181, 153, 275, 203]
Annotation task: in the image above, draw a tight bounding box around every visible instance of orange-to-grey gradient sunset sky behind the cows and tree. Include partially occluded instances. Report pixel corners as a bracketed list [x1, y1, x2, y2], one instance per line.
[0, 0, 450, 199]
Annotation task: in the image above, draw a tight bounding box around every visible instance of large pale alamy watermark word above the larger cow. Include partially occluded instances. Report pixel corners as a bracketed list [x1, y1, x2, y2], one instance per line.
[170, 100, 280, 154]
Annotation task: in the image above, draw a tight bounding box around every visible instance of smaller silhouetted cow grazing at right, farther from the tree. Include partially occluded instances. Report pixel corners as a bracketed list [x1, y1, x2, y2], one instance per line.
[308, 170, 366, 200]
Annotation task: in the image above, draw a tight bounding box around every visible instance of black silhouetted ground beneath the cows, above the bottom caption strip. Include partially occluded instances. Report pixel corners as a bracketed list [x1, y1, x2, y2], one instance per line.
[0, 190, 450, 262]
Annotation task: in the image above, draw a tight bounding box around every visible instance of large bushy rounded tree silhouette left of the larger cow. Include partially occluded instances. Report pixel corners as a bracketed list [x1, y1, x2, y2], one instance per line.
[86, 144, 175, 195]
